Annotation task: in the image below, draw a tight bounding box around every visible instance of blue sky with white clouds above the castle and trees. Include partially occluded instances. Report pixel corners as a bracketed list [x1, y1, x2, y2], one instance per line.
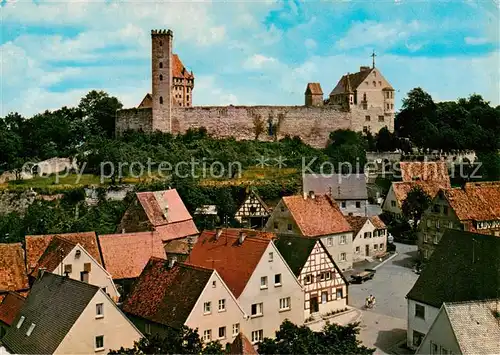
[0, 0, 500, 117]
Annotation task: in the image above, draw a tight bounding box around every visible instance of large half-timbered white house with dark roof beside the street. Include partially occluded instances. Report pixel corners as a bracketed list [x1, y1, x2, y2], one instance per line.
[275, 236, 349, 318]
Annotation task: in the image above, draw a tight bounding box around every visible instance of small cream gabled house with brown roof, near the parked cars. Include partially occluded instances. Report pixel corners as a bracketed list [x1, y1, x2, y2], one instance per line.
[346, 216, 387, 262]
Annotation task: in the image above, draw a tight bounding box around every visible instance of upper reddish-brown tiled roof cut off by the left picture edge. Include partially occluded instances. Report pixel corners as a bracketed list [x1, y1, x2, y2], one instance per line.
[0, 243, 29, 292]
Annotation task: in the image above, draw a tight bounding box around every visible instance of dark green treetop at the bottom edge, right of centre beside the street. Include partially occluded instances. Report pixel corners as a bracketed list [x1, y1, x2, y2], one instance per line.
[258, 320, 375, 355]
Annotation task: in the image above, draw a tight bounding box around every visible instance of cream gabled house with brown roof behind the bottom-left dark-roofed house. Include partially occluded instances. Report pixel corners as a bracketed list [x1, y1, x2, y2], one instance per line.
[29, 236, 120, 302]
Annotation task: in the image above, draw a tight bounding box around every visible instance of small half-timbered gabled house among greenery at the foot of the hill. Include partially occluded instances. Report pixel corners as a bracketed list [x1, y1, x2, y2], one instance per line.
[234, 190, 271, 229]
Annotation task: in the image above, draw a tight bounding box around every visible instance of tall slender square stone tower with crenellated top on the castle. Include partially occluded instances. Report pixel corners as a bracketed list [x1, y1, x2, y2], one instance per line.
[151, 30, 174, 132]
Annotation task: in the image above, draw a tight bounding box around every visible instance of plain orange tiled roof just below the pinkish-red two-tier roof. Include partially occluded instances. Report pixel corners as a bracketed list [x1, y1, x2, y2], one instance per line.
[99, 232, 166, 280]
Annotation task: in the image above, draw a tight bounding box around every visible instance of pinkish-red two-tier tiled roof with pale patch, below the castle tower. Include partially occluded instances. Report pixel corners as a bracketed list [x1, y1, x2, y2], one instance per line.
[136, 189, 199, 241]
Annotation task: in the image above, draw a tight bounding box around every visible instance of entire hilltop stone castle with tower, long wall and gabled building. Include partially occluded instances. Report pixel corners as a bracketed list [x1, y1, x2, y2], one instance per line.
[115, 30, 394, 147]
